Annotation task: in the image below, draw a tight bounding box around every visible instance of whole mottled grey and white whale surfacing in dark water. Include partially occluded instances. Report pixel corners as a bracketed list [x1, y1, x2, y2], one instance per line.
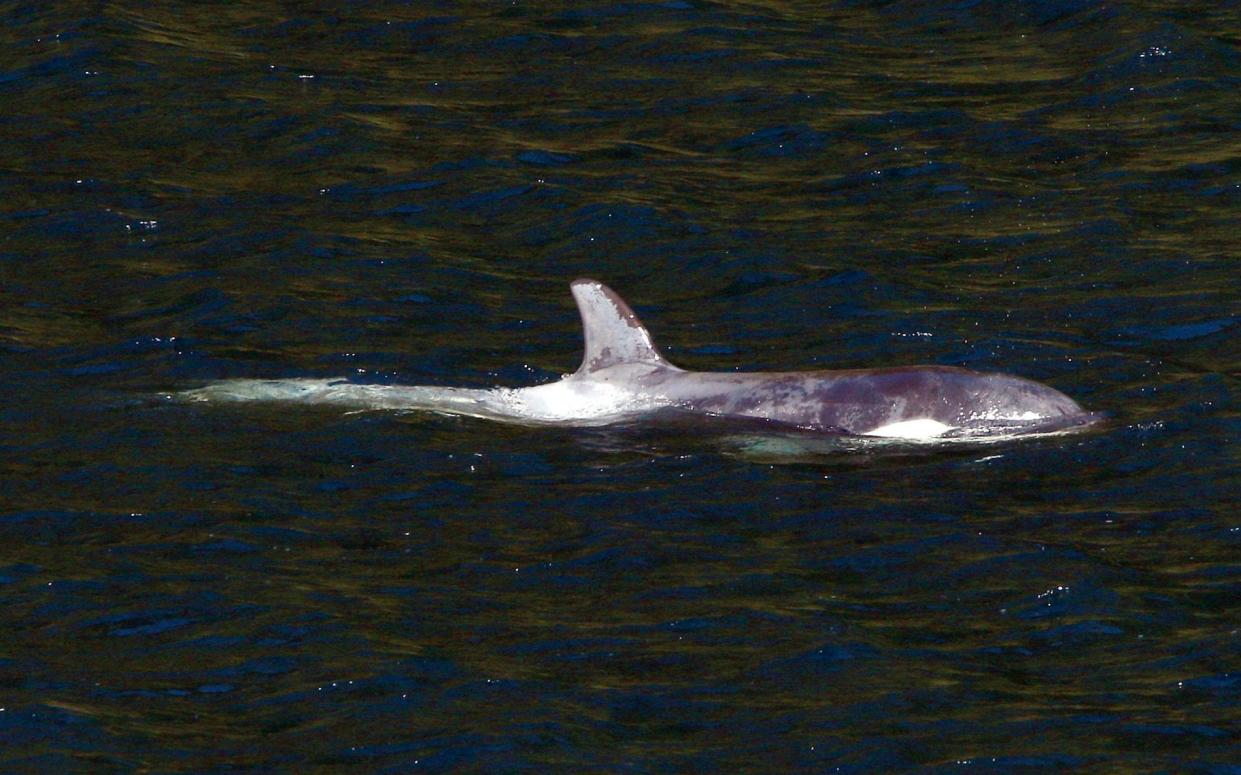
[179, 279, 1098, 440]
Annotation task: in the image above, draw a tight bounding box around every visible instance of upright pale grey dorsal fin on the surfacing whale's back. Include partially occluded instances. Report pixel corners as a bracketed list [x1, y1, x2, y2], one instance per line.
[570, 279, 676, 375]
